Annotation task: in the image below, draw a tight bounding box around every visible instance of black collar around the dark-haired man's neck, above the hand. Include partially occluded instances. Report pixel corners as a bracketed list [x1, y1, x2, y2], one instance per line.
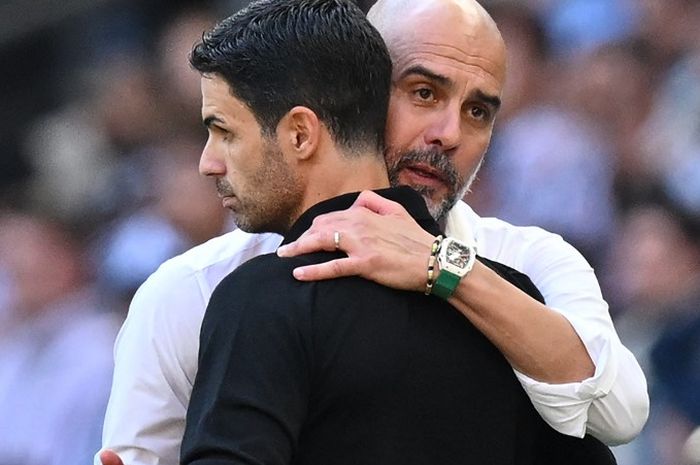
[282, 186, 441, 244]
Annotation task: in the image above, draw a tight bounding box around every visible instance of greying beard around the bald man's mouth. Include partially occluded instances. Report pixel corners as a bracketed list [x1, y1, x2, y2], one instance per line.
[387, 149, 483, 222]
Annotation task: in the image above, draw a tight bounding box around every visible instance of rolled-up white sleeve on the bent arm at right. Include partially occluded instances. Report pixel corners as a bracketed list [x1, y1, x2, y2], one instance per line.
[508, 232, 649, 445]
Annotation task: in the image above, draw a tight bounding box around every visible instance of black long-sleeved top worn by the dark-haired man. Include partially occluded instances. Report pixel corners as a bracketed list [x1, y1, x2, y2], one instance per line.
[182, 188, 614, 465]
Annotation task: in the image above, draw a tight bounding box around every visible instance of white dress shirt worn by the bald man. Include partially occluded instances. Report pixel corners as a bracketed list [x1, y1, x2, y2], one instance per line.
[95, 202, 649, 465]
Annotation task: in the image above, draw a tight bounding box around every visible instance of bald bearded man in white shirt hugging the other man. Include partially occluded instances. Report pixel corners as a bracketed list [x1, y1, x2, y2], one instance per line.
[96, 0, 648, 465]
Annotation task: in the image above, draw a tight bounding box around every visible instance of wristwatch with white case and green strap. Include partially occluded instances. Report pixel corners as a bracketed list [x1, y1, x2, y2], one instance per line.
[432, 237, 476, 299]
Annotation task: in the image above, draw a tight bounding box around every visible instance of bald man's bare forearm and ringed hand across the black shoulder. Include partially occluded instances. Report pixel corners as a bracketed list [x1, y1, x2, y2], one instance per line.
[278, 192, 595, 384]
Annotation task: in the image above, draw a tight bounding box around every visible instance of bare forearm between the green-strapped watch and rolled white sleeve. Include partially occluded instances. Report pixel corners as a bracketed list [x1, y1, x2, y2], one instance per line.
[449, 262, 595, 384]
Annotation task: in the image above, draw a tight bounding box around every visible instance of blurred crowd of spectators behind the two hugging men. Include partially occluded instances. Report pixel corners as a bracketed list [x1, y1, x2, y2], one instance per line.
[0, 0, 700, 465]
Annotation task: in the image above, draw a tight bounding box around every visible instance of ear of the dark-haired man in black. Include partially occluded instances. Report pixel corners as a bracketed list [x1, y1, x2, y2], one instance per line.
[277, 106, 323, 160]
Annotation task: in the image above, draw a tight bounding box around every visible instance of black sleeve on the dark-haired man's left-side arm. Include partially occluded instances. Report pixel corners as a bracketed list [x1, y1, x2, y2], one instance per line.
[181, 265, 310, 465]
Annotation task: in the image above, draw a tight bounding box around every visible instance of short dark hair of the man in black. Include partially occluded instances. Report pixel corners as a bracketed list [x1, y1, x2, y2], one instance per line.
[190, 0, 391, 150]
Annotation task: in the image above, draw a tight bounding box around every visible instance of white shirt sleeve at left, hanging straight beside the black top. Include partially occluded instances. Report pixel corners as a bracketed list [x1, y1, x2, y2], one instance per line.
[95, 264, 206, 465]
